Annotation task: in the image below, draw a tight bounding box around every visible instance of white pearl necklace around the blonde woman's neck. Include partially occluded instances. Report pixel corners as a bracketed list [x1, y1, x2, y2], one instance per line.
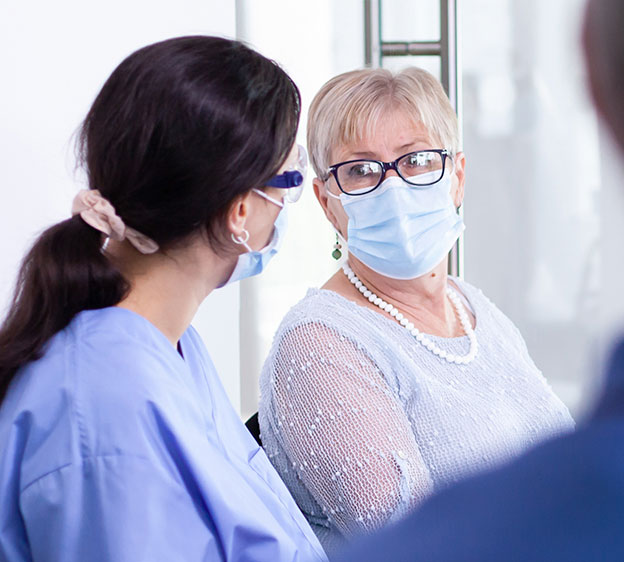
[342, 263, 479, 365]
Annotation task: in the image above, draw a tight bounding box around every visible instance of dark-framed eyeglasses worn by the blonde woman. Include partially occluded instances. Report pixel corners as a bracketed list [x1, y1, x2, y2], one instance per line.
[328, 148, 450, 196]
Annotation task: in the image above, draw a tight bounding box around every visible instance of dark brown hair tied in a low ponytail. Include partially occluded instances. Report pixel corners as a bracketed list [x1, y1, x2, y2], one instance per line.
[0, 36, 300, 399]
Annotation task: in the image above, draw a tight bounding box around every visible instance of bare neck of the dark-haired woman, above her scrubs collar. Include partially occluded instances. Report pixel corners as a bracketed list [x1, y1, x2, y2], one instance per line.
[107, 236, 232, 347]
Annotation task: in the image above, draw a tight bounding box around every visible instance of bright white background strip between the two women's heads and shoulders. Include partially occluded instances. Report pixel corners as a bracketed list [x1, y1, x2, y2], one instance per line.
[237, 0, 364, 417]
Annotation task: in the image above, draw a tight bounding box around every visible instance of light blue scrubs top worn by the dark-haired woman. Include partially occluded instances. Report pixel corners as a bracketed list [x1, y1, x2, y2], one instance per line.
[0, 308, 326, 562]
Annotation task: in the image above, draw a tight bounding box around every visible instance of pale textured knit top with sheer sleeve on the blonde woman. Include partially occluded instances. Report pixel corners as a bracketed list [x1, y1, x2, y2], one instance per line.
[259, 279, 573, 552]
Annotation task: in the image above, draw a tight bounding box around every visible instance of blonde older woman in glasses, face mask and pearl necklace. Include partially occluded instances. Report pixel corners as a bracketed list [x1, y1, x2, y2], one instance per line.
[259, 68, 573, 552]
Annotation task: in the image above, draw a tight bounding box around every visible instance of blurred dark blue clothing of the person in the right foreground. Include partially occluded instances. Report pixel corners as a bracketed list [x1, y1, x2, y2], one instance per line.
[335, 342, 624, 562]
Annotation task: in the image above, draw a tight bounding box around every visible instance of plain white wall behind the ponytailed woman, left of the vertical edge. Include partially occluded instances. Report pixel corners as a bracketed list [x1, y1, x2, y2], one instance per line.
[0, 0, 240, 408]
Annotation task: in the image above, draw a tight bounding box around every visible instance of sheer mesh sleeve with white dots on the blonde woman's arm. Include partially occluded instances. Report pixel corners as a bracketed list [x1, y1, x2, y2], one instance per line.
[265, 323, 432, 536]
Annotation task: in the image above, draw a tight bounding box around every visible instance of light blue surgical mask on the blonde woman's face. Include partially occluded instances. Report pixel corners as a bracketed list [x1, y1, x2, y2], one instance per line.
[340, 168, 464, 279]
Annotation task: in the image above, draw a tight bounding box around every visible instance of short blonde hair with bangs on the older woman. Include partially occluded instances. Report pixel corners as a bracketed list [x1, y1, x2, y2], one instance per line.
[307, 67, 460, 180]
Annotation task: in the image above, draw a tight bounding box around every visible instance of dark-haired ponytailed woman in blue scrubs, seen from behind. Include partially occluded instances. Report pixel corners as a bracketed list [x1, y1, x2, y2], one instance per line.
[0, 37, 324, 562]
